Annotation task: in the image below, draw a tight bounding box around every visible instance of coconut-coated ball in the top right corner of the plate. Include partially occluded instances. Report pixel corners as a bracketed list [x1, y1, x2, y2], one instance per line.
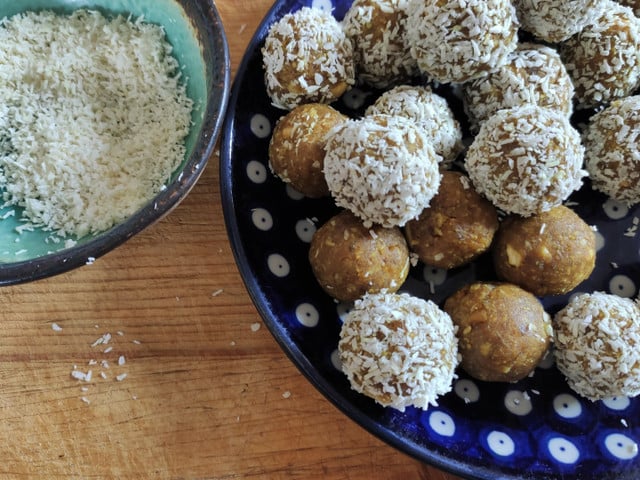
[560, 0, 640, 108]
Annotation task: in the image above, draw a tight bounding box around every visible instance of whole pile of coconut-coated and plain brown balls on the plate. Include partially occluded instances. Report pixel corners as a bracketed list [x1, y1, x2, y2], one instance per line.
[262, 0, 640, 410]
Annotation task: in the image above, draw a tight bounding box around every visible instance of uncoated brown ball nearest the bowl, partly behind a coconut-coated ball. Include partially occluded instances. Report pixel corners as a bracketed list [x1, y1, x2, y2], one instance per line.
[269, 103, 347, 198]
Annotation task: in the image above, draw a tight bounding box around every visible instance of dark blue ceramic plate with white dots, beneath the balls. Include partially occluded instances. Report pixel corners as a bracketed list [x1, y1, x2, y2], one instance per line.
[220, 0, 640, 480]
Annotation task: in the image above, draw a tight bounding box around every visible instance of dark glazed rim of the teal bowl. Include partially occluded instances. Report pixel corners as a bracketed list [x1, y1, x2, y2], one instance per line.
[0, 0, 231, 286]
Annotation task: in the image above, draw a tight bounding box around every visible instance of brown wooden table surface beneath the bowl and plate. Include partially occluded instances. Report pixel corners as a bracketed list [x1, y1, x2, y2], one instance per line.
[0, 0, 454, 480]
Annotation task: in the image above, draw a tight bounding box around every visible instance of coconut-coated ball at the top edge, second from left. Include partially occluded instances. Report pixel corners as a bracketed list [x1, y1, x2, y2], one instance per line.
[342, 0, 418, 88]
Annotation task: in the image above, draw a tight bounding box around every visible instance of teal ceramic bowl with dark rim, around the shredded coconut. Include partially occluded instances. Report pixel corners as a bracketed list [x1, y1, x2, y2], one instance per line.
[0, 0, 230, 285]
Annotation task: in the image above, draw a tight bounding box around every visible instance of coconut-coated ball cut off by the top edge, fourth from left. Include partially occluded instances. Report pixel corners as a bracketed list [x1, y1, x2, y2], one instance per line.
[513, 0, 602, 43]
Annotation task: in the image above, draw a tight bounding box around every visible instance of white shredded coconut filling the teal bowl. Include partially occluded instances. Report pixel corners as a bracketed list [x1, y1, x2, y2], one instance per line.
[0, 10, 193, 237]
